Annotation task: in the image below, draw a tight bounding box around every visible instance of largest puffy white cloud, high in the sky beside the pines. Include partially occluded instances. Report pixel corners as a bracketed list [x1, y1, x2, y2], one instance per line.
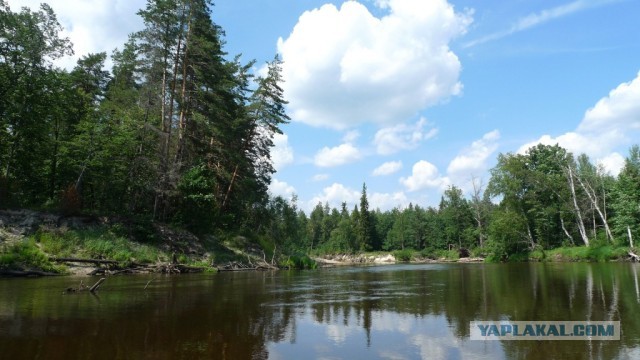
[278, 0, 472, 129]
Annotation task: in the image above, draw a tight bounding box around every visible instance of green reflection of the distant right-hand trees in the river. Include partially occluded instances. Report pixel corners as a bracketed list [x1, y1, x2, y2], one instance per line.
[276, 263, 640, 359]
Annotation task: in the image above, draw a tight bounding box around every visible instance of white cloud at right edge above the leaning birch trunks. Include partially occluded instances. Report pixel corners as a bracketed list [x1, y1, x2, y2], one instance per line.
[518, 73, 640, 174]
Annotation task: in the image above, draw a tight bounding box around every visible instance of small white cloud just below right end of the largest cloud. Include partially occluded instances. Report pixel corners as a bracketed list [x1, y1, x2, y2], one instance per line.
[373, 118, 438, 155]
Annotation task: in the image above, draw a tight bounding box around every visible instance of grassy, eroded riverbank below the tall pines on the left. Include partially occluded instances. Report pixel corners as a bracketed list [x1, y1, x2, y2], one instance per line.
[0, 210, 273, 276]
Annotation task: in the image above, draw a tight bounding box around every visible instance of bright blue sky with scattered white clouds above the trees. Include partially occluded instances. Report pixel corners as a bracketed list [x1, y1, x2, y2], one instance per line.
[8, 0, 640, 210]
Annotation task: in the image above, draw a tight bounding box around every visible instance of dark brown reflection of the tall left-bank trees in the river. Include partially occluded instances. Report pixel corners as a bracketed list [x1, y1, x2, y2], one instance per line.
[0, 274, 294, 359]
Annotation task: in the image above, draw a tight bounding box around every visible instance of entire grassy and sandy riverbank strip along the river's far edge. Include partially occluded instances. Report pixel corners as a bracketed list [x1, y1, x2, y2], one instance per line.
[0, 210, 638, 276]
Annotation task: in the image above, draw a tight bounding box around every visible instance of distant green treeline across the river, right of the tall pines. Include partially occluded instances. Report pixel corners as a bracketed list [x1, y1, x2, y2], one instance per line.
[267, 145, 640, 260]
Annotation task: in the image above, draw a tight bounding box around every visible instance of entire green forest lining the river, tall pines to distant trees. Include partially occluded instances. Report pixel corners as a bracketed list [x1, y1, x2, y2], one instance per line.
[0, 0, 640, 261]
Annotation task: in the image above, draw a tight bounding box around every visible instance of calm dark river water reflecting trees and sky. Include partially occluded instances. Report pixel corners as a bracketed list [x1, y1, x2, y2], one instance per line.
[0, 263, 640, 359]
